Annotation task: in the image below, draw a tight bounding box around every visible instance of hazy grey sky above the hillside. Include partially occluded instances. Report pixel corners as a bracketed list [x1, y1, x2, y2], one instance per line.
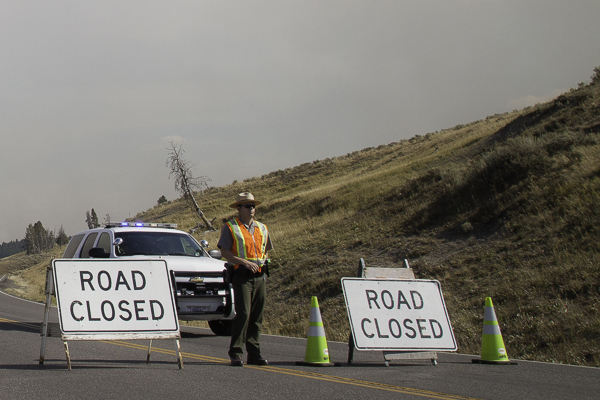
[0, 0, 600, 242]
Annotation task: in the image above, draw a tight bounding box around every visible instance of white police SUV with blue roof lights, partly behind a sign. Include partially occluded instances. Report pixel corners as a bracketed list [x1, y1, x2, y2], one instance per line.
[63, 222, 235, 335]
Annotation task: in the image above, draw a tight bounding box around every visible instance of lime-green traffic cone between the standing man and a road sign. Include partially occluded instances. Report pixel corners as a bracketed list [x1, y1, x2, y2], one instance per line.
[296, 296, 336, 367]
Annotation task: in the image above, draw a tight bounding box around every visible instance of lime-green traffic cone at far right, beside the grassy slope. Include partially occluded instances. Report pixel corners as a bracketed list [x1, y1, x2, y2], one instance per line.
[471, 297, 517, 364]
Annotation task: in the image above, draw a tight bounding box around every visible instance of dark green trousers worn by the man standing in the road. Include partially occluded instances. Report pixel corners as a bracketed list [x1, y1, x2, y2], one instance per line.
[229, 267, 266, 358]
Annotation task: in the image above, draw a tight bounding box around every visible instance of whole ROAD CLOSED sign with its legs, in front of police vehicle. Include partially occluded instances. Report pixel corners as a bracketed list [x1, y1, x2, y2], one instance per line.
[39, 258, 183, 370]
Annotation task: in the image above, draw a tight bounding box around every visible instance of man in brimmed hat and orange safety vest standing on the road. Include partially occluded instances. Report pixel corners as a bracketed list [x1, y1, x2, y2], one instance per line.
[217, 193, 273, 367]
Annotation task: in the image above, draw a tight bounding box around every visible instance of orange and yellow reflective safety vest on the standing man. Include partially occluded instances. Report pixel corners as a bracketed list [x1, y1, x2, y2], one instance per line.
[227, 218, 269, 272]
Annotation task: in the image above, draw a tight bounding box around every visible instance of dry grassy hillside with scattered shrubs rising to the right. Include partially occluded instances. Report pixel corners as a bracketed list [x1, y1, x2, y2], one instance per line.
[4, 68, 600, 366]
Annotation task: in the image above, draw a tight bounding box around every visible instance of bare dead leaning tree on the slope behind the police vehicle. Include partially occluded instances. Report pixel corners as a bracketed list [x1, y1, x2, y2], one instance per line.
[166, 142, 216, 231]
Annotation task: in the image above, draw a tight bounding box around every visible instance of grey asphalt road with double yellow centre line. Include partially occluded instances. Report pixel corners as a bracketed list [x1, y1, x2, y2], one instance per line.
[0, 292, 600, 400]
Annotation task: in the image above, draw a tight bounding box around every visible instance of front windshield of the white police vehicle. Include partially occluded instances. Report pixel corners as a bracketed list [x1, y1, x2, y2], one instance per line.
[115, 231, 205, 257]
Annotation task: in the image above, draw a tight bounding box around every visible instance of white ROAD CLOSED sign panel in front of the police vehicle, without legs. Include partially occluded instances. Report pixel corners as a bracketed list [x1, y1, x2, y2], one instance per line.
[52, 259, 179, 340]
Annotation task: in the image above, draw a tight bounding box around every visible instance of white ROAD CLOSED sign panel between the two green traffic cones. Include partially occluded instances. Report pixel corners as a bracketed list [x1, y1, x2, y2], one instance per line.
[342, 278, 457, 351]
